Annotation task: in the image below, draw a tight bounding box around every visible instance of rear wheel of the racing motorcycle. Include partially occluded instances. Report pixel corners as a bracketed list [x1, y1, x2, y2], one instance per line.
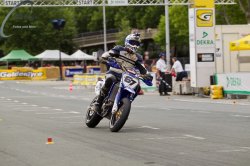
[85, 96, 103, 128]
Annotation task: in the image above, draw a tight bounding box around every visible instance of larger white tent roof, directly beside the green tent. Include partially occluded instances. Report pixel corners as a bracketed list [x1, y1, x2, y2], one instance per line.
[35, 50, 73, 61]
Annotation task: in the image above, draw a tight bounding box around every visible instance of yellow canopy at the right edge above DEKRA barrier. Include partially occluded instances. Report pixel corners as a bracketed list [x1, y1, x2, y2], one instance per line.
[230, 35, 250, 51]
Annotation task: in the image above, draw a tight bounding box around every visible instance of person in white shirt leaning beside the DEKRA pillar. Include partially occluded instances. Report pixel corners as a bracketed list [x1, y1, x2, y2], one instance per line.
[171, 57, 187, 81]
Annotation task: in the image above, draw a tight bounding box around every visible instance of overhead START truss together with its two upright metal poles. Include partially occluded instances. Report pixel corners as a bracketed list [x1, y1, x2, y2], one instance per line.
[0, 0, 235, 67]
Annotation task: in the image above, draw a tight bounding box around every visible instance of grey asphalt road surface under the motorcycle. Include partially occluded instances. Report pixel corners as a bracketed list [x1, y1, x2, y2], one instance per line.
[0, 81, 250, 166]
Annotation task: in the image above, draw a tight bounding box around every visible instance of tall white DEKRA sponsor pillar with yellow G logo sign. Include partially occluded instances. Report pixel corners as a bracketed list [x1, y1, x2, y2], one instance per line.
[189, 6, 216, 87]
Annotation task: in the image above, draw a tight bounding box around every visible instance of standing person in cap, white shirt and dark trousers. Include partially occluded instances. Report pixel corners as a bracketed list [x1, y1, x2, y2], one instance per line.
[156, 52, 169, 96]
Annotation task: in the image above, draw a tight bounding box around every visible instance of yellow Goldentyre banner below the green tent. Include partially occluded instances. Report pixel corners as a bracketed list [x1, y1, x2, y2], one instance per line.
[0, 68, 47, 80]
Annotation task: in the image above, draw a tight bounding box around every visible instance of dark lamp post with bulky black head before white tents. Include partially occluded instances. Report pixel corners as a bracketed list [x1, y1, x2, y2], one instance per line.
[52, 19, 66, 80]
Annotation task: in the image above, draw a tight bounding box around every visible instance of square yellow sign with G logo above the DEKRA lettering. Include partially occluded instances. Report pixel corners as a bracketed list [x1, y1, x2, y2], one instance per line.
[196, 9, 214, 27]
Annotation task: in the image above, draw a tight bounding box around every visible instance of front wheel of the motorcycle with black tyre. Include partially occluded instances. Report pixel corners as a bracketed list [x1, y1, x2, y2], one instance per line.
[109, 98, 131, 132]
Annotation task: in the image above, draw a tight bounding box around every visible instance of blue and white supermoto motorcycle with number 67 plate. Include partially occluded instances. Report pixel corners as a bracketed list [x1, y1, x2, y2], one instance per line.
[85, 59, 152, 132]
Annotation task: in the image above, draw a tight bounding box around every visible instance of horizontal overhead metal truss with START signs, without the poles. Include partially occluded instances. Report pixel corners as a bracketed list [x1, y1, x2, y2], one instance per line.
[0, 0, 235, 7]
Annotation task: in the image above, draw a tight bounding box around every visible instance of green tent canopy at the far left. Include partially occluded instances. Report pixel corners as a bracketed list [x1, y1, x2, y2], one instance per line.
[0, 50, 37, 62]
